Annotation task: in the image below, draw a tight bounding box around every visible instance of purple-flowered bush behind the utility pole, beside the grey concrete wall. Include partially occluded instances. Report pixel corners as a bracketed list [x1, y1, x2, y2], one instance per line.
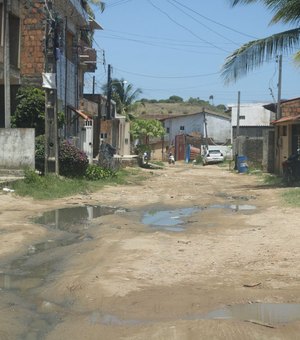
[35, 135, 89, 177]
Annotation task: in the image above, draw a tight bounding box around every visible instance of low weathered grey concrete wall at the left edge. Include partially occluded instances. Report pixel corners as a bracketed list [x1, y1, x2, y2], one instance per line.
[0, 129, 35, 169]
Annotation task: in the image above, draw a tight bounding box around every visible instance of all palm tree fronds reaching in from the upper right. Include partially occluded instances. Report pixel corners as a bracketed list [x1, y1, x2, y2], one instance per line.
[222, 0, 300, 83]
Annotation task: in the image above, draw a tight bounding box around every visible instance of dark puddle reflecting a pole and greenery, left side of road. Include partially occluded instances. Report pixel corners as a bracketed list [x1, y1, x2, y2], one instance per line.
[34, 205, 118, 232]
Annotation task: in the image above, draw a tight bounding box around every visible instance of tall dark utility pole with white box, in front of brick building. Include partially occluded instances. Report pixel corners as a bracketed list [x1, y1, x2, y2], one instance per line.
[43, 0, 59, 175]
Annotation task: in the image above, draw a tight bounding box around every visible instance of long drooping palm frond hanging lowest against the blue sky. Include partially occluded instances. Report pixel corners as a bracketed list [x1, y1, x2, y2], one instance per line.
[221, 28, 300, 83]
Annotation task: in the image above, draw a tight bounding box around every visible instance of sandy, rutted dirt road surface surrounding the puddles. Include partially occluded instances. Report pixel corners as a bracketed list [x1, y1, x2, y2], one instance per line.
[0, 163, 300, 340]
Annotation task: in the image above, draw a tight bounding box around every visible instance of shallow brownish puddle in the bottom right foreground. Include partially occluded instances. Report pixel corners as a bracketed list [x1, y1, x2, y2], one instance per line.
[192, 303, 300, 325]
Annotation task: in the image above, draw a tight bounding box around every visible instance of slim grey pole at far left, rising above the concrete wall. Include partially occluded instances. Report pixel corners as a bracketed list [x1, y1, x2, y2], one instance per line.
[3, 0, 11, 129]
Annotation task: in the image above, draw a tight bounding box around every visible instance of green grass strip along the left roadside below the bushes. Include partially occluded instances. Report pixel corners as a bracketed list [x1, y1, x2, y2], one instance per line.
[8, 168, 147, 200]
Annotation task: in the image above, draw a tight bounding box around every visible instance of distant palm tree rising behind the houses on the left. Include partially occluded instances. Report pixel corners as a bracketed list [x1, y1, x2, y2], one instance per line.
[102, 78, 142, 118]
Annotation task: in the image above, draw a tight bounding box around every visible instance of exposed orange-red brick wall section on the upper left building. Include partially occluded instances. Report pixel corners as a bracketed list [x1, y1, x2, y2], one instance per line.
[20, 0, 45, 85]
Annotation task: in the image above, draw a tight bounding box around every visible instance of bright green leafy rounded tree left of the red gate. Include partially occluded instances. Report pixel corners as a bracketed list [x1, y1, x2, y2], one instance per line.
[130, 119, 165, 152]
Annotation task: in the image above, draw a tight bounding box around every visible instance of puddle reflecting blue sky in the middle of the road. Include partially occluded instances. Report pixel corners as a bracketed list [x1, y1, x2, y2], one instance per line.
[142, 204, 256, 232]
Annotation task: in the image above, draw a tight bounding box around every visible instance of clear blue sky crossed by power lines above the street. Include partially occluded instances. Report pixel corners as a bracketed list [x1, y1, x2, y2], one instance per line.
[85, 0, 300, 105]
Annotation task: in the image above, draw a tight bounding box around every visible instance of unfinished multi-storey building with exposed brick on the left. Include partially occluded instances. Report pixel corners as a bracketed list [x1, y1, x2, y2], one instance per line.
[0, 0, 101, 169]
